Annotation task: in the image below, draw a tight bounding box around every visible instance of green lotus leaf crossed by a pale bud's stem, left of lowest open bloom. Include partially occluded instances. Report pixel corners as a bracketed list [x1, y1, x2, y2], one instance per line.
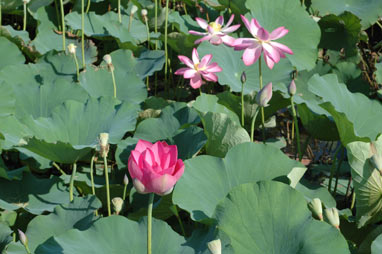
[80, 50, 147, 104]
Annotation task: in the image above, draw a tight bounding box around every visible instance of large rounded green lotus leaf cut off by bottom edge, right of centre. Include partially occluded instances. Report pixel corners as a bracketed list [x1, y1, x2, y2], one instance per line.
[215, 181, 350, 254]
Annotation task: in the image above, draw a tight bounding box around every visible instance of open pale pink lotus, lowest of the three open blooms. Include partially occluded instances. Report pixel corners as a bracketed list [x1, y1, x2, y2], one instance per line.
[175, 48, 223, 89]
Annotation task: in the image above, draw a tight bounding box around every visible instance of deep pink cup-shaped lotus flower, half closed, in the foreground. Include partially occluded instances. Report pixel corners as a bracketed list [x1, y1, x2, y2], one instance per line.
[128, 139, 184, 195]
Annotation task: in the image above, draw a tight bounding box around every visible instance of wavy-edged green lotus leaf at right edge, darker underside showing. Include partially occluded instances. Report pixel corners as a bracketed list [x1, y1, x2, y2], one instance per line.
[308, 74, 382, 145]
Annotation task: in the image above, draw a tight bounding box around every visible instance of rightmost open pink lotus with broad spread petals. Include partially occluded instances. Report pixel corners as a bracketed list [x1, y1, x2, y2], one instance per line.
[234, 15, 293, 69]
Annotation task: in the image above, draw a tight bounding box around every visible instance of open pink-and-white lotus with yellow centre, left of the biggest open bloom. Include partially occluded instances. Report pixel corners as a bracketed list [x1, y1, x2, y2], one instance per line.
[189, 14, 240, 47]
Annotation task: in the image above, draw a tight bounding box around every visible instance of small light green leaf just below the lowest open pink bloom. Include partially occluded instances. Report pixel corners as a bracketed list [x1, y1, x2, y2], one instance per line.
[192, 93, 240, 124]
